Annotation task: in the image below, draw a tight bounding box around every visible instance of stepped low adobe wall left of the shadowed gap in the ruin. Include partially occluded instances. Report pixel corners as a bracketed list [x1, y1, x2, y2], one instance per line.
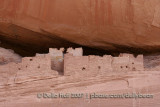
[0, 54, 58, 72]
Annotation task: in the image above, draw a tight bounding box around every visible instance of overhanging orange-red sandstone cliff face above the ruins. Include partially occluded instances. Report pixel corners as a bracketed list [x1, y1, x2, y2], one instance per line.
[0, 0, 160, 51]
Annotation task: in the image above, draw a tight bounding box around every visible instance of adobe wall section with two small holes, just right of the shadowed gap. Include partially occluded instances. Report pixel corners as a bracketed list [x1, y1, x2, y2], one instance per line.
[64, 54, 112, 75]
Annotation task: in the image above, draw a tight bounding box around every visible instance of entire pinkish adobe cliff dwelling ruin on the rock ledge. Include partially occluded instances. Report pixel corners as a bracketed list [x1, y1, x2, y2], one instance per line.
[0, 48, 144, 75]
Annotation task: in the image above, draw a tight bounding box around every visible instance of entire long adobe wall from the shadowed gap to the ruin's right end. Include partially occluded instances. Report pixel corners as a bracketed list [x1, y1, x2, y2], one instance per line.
[64, 49, 144, 75]
